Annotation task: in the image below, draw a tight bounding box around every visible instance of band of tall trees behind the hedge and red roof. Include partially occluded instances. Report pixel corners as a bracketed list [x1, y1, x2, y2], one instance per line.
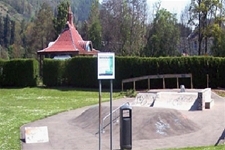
[0, 0, 225, 59]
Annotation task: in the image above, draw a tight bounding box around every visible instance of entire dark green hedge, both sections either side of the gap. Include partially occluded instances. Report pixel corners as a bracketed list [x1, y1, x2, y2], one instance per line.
[0, 57, 225, 89]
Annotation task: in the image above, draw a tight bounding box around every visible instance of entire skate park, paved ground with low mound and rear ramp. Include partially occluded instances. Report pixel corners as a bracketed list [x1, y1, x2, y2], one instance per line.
[21, 74, 225, 150]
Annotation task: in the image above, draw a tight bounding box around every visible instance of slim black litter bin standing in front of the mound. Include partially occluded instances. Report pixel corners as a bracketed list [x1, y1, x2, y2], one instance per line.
[120, 104, 132, 150]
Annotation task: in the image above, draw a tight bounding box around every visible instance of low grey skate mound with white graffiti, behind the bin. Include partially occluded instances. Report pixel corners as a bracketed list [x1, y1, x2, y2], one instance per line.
[71, 106, 199, 140]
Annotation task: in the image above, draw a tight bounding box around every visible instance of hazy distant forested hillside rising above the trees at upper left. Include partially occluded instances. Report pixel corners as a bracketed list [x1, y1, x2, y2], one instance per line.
[0, 0, 93, 21]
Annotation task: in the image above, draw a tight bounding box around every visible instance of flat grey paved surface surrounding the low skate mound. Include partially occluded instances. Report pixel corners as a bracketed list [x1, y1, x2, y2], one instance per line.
[21, 92, 225, 150]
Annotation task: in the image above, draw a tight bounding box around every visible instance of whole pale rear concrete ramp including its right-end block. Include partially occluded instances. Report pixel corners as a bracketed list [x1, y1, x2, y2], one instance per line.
[132, 88, 214, 111]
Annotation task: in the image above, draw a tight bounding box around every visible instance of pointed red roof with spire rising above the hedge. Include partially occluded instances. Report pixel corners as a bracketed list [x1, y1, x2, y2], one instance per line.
[38, 9, 98, 55]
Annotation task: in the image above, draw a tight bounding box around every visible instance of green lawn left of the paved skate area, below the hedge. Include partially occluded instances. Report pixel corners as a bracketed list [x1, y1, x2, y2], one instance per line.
[0, 88, 120, 150]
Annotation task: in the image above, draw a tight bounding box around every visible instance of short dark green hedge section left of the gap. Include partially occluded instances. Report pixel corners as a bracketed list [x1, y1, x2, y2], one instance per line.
[0, 59, 39, 87]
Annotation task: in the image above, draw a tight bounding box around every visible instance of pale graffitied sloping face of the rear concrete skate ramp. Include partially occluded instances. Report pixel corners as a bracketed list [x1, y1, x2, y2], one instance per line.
[132, 92, 198, 110]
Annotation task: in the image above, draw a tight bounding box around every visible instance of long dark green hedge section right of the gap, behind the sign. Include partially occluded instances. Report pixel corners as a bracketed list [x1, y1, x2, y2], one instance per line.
[43, 56, 225, 89]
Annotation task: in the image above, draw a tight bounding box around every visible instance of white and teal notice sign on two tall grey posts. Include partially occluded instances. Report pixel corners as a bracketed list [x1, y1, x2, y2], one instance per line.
[97, 52, 115, 150]
